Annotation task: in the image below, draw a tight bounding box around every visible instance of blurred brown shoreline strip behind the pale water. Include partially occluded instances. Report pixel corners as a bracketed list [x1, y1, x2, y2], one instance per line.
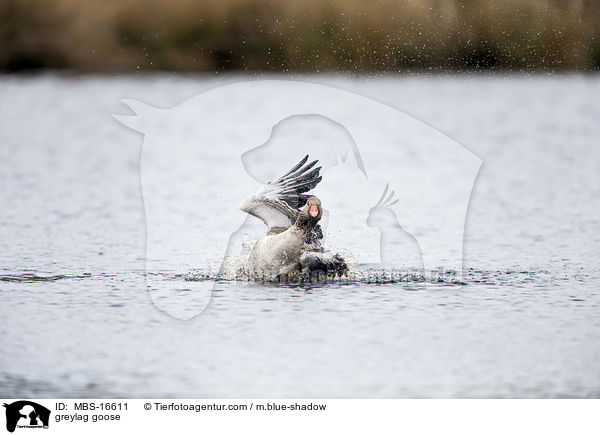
[0, 0, 600, 75]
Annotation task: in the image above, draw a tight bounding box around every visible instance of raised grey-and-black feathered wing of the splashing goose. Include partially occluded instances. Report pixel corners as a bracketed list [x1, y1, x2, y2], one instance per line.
[240, 155, 322, 233]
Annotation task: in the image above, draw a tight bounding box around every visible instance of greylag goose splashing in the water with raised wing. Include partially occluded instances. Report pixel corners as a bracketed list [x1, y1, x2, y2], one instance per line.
[240, 155, 348, 281]
